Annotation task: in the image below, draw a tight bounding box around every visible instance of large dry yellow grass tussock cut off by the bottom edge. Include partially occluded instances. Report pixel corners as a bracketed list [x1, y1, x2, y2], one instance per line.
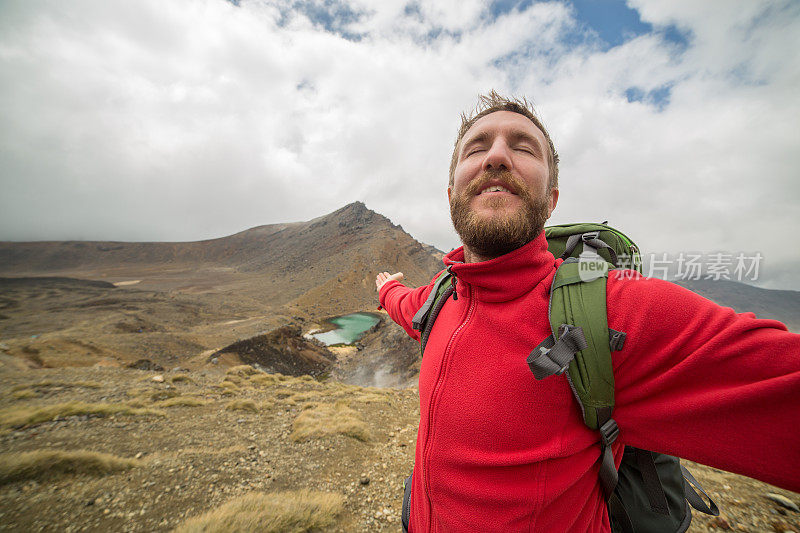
[174, 490, 344, 533]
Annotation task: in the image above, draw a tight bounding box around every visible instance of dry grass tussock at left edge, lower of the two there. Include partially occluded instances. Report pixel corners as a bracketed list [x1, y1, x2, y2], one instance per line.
[0, 450, 141, 485]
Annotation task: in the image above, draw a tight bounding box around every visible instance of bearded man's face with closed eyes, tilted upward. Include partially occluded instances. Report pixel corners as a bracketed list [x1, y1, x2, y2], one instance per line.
[447, 111, 558, 258]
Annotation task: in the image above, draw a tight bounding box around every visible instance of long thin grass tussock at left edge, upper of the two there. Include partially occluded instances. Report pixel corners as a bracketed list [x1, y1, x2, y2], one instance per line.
[0, 402, 164, 428]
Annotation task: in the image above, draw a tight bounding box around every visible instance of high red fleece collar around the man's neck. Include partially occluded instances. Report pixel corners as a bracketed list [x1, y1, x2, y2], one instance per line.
[443, 231, 556, 302]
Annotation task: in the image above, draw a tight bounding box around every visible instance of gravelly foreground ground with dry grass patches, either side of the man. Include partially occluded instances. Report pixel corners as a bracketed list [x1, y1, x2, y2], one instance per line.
[0, 365, 800, 532]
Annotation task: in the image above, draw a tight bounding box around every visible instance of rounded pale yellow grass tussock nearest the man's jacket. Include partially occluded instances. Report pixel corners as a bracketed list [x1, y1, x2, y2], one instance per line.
[291, 402, 370, 442]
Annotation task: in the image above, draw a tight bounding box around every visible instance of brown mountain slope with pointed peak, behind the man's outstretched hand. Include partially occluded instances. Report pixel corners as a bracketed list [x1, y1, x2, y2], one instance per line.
[0, 202, 441, 317]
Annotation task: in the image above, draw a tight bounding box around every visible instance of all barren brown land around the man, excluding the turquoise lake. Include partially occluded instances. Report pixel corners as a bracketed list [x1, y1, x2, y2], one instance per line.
[0, 204, 800, 533]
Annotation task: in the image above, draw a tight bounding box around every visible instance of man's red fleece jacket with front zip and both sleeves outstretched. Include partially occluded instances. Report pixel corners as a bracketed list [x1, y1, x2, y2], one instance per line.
[380, 233, 800, 533]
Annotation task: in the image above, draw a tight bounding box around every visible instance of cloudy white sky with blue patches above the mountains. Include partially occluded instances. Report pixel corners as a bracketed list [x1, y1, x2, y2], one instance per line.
[0, 0, 800, 289]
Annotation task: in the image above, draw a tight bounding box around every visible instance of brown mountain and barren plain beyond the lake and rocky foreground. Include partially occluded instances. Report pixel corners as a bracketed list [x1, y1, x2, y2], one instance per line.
[0, 202, 441, 373]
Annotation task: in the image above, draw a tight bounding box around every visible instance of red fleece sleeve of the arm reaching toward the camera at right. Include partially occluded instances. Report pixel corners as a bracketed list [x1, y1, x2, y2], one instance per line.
[608, 276, 800, 491]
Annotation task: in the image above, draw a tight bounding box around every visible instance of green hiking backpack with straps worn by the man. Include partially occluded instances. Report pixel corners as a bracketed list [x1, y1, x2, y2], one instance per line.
[403, 223, 719, 533]
